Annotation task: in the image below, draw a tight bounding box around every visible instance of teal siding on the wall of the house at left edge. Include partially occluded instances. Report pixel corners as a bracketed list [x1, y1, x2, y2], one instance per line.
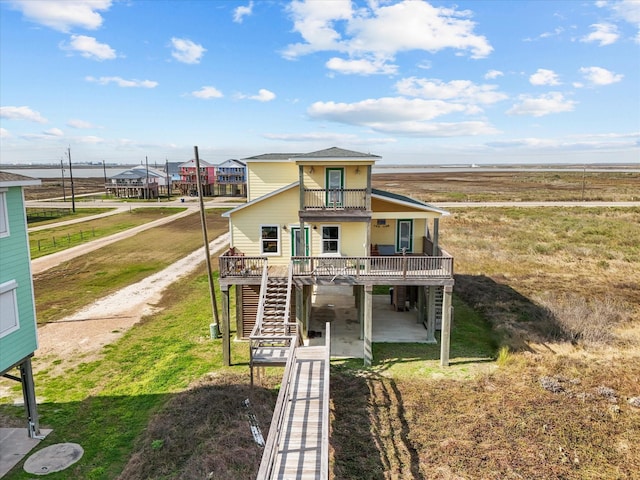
[0, 187, 38, 371]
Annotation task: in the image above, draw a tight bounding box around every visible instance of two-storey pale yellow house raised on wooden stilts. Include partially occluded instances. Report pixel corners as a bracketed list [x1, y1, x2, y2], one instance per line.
[220, 147, 454, 365]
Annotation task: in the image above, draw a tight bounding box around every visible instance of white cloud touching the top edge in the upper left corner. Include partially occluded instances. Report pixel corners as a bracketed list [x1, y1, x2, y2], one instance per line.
[11, 0, 112, 33]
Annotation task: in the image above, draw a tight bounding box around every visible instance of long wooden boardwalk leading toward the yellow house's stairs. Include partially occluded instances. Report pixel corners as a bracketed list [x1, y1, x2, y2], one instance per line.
[272, 346, 329, 480]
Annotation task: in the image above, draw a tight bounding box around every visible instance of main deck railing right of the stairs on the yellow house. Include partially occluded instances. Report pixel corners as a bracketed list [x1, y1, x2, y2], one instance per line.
[292, 255, 453, 280]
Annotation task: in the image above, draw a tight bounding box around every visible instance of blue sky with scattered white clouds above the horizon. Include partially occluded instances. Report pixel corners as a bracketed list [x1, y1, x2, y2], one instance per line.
[0, 0, 640, 165]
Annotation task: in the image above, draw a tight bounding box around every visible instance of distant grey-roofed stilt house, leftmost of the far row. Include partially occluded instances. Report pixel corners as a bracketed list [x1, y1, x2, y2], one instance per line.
[105, 165, 166, 199]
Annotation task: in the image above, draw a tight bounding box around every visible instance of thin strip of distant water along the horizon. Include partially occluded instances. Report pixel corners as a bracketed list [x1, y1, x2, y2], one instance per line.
[0, 165, 640, 178]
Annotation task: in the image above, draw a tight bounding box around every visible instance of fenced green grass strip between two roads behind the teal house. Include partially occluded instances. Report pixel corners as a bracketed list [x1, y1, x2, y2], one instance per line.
[29, 208, 184, 259]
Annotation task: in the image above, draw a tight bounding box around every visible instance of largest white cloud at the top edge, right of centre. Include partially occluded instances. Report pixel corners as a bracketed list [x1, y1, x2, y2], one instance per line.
[283, 0, 493, 75]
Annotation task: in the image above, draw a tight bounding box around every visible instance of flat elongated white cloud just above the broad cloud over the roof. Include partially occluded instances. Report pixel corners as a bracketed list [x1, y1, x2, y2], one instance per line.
[396, 77, 508, 104]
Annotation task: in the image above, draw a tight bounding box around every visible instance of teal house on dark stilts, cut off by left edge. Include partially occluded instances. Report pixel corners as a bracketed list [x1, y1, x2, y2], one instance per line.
[0, 172, 41, 438]
